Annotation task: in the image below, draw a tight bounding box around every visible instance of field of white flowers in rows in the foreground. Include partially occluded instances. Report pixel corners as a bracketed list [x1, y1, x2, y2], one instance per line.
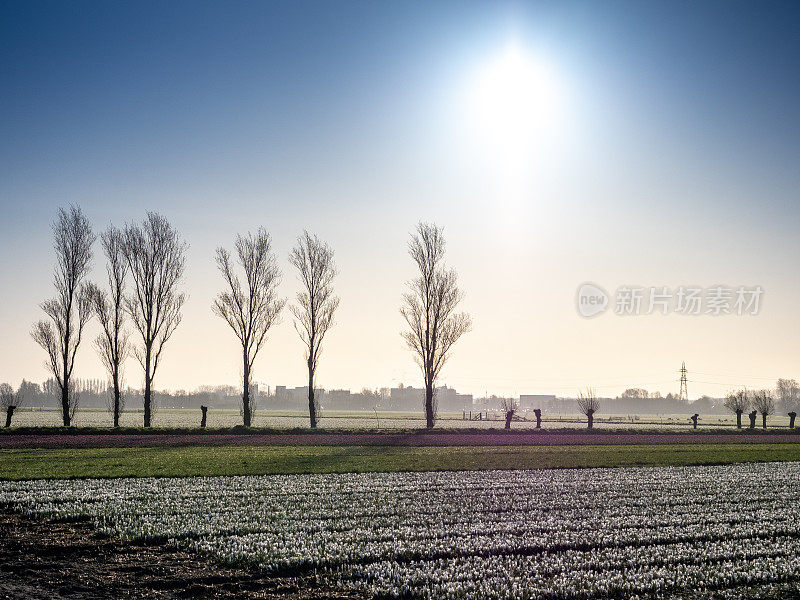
[0, 463, 800, 599]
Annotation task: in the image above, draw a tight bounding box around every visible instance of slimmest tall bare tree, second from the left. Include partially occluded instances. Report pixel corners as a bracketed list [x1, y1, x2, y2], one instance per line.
[91, 226, 130, 427]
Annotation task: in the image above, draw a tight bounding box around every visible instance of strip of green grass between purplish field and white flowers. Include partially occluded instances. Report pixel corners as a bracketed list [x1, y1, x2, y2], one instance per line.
[0, 444, 800, 479]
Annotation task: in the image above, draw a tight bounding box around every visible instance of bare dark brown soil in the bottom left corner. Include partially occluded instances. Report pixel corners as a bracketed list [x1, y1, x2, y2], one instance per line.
[0, 511, 368, 600]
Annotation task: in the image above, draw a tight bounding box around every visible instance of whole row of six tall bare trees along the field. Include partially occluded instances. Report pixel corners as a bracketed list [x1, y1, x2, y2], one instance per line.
[31, 206, 471, 428]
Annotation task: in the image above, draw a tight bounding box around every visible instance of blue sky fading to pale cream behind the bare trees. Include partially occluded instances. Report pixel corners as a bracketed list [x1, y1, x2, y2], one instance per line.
[0, 1, 800, 398]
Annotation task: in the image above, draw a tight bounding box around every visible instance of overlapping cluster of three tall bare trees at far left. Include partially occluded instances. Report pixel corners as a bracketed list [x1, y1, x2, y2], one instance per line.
[31, 206, 187, 427]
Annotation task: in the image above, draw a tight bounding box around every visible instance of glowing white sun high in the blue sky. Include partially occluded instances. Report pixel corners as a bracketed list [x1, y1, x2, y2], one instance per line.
[470, 44, 558, 160]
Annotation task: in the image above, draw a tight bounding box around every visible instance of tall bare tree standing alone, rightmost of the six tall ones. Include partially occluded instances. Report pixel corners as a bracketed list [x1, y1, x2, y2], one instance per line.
[400, 223, 472, 429]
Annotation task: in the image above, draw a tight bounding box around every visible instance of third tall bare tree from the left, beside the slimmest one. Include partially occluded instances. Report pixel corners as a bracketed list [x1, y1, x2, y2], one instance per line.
[122, 212, 187, 427]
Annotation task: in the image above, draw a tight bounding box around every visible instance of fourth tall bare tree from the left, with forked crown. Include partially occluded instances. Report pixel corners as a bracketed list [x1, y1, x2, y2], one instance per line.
[212, 227, 286, 427]
